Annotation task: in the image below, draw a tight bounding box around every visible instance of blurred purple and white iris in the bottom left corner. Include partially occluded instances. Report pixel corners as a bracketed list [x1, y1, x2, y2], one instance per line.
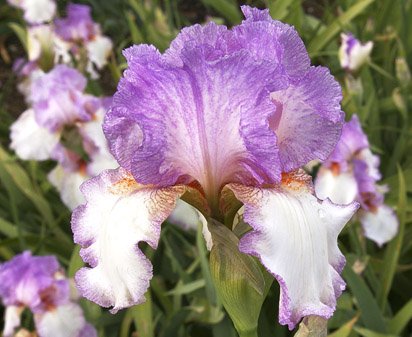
[0, 251, 97, 337]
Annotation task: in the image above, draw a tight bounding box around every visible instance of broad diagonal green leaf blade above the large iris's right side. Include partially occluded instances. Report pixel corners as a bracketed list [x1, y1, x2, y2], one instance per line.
[308, 0, 375, 55]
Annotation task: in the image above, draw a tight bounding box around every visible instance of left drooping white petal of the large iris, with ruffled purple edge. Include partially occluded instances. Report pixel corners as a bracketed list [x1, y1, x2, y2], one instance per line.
[72, 168, 185, 312]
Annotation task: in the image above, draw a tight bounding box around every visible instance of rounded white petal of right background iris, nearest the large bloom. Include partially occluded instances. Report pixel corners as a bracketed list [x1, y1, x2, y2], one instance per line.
[315, 167, 358, 205]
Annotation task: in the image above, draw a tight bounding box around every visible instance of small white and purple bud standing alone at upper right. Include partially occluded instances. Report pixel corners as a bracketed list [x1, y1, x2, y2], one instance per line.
[339, 33, 373, 71]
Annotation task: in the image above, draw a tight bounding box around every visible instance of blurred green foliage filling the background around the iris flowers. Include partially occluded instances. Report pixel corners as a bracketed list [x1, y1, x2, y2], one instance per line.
[0, 0, 412, 337]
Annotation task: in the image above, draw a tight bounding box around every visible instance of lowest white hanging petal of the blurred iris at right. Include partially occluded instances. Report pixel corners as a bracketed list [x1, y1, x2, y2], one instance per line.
[359, 205, 399, 246]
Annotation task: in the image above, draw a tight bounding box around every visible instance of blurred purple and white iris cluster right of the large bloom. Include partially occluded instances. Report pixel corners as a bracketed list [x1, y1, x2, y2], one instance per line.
[315, 115, 398, 246]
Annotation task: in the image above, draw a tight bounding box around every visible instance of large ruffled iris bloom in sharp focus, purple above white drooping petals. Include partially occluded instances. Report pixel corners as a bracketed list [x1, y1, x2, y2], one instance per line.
[72, 7, 357, 328]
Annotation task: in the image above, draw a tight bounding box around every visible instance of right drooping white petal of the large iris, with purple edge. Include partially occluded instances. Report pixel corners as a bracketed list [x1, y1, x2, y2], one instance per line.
[230, 175, 358, 329]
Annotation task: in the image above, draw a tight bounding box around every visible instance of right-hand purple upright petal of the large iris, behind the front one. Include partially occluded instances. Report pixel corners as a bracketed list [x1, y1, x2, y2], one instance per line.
[271, 67, 344, 172]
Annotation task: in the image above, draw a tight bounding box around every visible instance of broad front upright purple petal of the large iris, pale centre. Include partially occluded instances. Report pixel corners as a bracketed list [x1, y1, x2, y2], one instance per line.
[103, 45, 284, 195]
